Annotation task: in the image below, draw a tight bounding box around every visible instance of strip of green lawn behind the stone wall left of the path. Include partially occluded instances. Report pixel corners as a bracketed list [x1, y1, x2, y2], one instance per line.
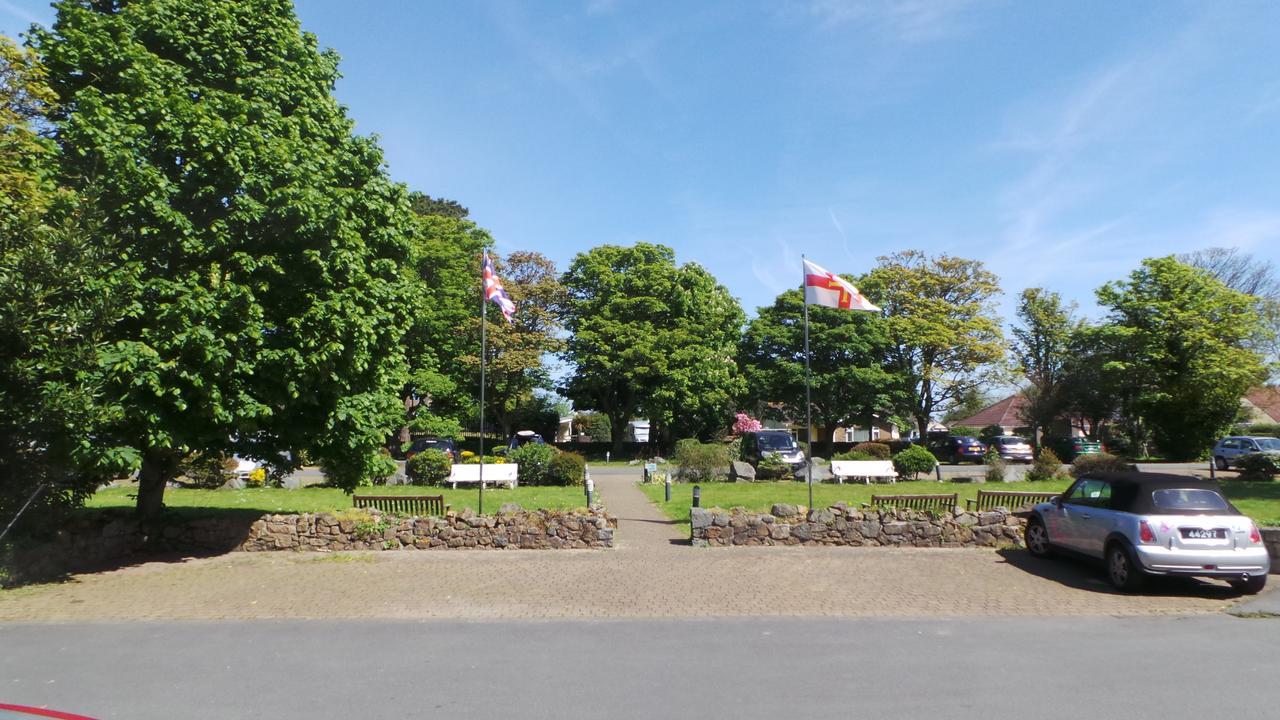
[86, 486, 586, 514]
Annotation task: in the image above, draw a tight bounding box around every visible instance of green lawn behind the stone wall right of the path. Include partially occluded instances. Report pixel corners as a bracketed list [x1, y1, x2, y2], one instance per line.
[639, 482, 1280, 533]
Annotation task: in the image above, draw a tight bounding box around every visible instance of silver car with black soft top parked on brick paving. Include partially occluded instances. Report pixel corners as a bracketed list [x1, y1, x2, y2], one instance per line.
[1027, 473, 1271, 594]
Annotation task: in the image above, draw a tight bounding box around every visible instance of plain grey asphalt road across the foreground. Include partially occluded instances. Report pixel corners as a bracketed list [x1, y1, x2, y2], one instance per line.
[0, 615, 1280, 720]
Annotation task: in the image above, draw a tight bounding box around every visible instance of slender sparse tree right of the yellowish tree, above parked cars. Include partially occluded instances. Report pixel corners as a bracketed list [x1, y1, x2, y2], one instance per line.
[1010, 287, 1079, 450]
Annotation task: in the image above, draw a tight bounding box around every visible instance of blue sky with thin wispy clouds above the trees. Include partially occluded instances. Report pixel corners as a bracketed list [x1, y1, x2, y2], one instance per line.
[0, 0, 1280, 319]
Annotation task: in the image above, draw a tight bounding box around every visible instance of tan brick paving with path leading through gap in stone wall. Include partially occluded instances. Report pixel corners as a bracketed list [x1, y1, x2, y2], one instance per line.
[0, 469, 1259, 621]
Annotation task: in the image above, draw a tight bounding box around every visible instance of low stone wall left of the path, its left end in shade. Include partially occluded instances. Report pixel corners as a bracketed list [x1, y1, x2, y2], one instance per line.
[0, 505, 618, 584]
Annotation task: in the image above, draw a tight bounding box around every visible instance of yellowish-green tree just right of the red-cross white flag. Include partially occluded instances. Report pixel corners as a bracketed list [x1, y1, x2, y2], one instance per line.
[861, 250, 1004, 437]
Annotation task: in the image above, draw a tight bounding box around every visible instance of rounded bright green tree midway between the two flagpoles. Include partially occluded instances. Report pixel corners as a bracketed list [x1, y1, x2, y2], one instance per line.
[562, 242, 745, 451]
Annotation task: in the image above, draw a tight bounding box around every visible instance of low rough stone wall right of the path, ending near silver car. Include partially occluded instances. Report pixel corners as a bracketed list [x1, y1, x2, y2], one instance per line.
[690, 503, 1025, 547]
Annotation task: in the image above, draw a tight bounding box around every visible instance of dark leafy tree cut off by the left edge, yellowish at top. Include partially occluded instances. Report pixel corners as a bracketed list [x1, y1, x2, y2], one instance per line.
[0, 36, 131, 527]
